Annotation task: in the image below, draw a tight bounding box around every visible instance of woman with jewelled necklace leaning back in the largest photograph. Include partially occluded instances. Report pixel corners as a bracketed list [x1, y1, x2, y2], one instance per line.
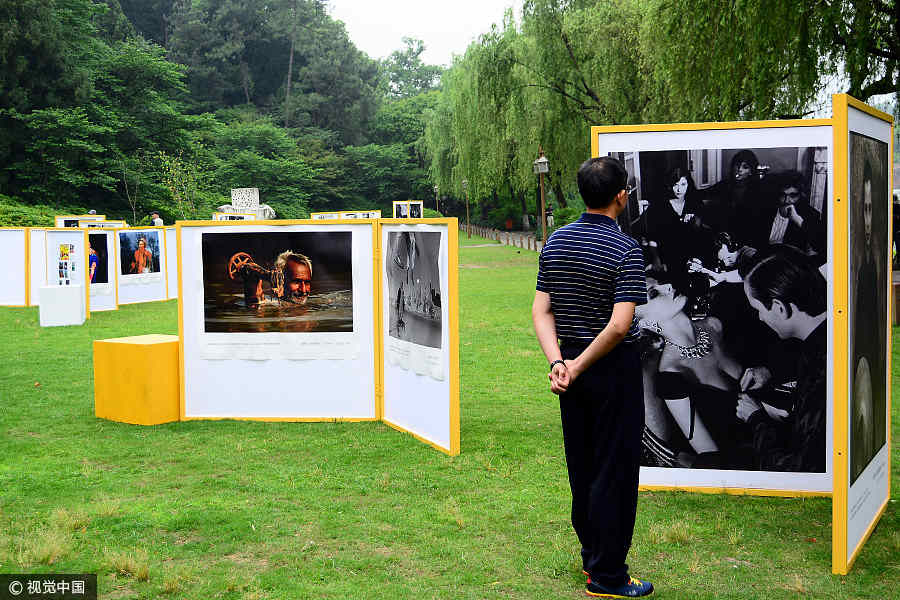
[635, 278, 742, 468]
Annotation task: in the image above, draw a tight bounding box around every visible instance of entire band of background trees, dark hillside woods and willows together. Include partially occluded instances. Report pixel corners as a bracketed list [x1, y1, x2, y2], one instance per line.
[0, 0, 900, 228]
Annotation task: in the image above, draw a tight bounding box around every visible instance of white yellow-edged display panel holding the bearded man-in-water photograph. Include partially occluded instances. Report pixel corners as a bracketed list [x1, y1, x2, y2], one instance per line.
[178, 222, 376, 420]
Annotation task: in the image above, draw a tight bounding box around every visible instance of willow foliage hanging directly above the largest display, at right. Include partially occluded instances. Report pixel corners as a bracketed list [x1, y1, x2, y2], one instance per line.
[641, 0, 900, 120]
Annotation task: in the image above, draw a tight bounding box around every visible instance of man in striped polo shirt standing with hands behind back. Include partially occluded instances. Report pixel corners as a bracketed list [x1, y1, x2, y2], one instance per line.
[531, 157, 653, 598]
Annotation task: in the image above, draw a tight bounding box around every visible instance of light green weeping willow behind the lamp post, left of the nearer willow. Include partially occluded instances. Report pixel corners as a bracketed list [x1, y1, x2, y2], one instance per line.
[429, 0, 648, 224]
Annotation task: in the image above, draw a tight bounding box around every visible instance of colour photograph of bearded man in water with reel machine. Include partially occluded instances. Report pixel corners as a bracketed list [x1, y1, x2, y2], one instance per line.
[202, 231, 353, 333]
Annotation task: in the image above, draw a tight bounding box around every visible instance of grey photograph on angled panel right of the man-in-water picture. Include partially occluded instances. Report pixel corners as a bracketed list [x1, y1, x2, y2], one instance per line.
[385, 231, 442, 348]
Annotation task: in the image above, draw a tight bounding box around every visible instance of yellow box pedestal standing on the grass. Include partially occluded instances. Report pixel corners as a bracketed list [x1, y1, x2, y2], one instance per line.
[94, 335, 179, 425]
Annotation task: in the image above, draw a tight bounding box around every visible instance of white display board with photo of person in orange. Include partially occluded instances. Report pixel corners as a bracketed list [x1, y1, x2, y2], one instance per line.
[115, 227, 168, 304]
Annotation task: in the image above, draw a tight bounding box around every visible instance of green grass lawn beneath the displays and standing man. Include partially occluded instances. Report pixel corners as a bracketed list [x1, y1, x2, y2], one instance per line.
[0, 233, 900, 600]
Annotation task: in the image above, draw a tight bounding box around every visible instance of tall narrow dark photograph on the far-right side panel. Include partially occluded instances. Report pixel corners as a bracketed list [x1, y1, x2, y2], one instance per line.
[848, 132, 890, 485]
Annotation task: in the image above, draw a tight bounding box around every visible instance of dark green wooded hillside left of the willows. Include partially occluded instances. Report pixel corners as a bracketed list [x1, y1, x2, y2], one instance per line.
[0, 0, 440, 224]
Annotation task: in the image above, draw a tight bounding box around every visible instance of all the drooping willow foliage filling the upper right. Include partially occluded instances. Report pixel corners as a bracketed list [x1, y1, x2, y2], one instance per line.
[426, 0, 900, 230]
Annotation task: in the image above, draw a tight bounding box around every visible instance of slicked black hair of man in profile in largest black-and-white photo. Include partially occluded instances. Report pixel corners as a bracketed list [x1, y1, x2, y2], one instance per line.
[745, 246, 827, 317]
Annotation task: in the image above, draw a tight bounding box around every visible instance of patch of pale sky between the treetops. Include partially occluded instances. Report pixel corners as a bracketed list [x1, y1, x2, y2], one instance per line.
[328, 0, 521, 65]
